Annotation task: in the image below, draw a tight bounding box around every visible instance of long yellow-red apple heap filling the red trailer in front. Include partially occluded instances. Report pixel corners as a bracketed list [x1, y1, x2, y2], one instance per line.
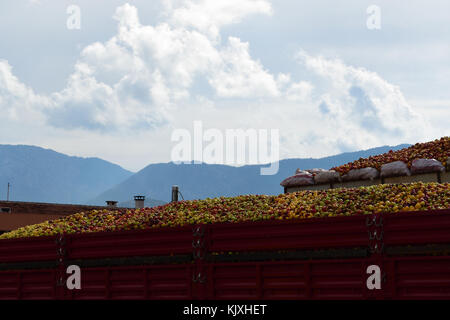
[0, 182, 450, 239]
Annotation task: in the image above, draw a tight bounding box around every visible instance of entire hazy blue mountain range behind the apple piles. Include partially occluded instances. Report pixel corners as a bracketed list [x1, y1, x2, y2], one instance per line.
[0, 144, 409, 207]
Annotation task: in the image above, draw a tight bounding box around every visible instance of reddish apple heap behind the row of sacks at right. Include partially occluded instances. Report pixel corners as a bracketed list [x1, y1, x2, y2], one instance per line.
[332, 137, 450, 175]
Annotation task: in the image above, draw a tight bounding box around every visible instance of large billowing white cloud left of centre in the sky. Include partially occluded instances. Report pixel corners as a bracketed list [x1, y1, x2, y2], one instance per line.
[42, 1, 279, 130]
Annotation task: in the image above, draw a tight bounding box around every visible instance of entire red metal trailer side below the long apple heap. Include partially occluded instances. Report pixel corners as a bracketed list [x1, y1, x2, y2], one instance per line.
[0, 210, 450, 300]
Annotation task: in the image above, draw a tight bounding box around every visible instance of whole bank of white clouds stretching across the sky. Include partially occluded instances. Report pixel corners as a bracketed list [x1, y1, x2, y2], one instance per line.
[0, 0, 442, 170]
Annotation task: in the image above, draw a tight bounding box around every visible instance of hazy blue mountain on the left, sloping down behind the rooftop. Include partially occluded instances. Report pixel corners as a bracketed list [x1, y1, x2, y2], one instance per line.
[0, 145, 133, 205]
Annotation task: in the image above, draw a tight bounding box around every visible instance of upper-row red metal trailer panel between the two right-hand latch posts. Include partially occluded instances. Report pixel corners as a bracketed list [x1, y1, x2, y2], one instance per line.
[207, 216, 368, 252]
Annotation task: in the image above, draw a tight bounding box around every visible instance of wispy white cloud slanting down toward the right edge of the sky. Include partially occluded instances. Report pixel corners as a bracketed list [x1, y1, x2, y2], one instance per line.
[298, 52, 426, 136]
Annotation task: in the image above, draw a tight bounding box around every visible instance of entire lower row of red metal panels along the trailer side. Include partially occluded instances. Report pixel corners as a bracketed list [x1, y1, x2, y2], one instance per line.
[0, 256, 450, 300]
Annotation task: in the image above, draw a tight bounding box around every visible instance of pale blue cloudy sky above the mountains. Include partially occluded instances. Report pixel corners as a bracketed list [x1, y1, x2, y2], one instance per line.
[0, 0, 450, 171]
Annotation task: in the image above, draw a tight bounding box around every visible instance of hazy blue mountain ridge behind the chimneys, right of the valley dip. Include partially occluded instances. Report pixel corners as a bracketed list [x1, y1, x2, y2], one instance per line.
[87, 144, 410, 204]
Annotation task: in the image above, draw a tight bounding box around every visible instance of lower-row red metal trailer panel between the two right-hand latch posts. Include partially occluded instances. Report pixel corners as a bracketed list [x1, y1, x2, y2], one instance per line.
[208, 259, 365, 300]
